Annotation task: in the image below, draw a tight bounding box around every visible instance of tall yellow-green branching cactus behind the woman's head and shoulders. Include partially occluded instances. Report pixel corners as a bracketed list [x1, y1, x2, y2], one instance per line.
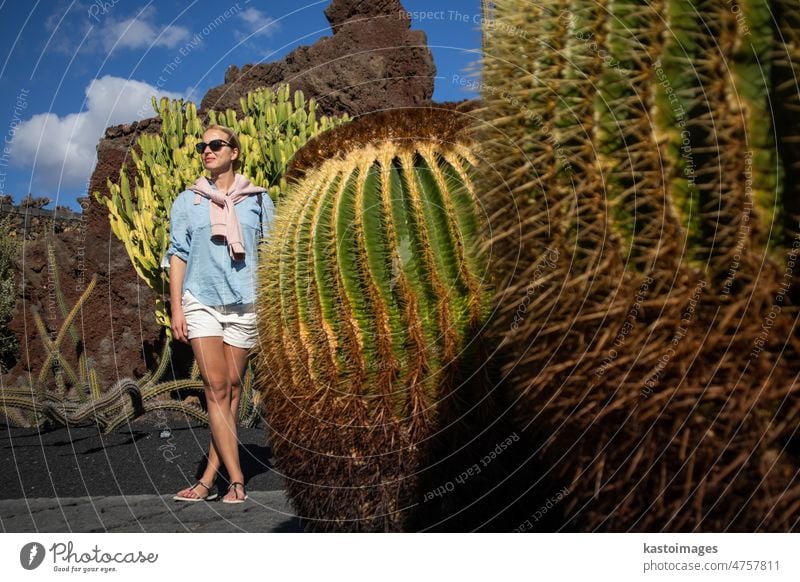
[94, 85, 348, 337]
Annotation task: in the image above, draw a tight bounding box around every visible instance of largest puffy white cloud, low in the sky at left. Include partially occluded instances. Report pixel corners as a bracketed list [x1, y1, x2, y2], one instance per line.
[11, 75, 181, 193]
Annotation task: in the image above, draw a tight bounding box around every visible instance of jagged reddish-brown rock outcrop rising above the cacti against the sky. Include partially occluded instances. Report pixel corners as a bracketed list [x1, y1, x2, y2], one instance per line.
[201, 0, 436, 116]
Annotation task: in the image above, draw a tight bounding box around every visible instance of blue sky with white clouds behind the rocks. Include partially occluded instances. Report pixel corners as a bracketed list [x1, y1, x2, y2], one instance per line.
[0, 0, 480, 209]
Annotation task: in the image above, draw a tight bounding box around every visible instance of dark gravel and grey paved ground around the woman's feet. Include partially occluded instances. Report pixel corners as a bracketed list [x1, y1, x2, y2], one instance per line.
[0, 422, 302, 532]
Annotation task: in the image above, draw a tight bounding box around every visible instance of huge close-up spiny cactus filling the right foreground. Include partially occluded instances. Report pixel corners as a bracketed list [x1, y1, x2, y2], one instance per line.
[477, 0, 800, 531]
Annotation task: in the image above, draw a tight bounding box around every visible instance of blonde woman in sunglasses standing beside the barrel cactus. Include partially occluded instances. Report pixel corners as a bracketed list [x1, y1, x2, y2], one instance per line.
[167, 125, 274, 503]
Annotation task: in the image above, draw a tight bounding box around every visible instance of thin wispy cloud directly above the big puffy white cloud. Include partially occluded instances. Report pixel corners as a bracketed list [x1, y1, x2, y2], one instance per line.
[98, 7, 189, 50]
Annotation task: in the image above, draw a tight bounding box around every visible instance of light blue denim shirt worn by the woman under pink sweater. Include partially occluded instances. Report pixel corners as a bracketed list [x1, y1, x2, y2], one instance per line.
[162, 190, 275, 306]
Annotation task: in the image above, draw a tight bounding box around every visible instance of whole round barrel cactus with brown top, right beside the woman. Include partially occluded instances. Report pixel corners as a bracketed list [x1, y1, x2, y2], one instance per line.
[257, 109, 488, 530]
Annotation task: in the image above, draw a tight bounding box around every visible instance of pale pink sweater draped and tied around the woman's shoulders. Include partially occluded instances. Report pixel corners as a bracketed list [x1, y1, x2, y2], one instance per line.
[189, 174, 267, 260]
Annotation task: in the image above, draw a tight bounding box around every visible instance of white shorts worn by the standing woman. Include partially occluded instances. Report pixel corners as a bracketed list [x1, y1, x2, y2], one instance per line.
[181, 291, 258, 349]
